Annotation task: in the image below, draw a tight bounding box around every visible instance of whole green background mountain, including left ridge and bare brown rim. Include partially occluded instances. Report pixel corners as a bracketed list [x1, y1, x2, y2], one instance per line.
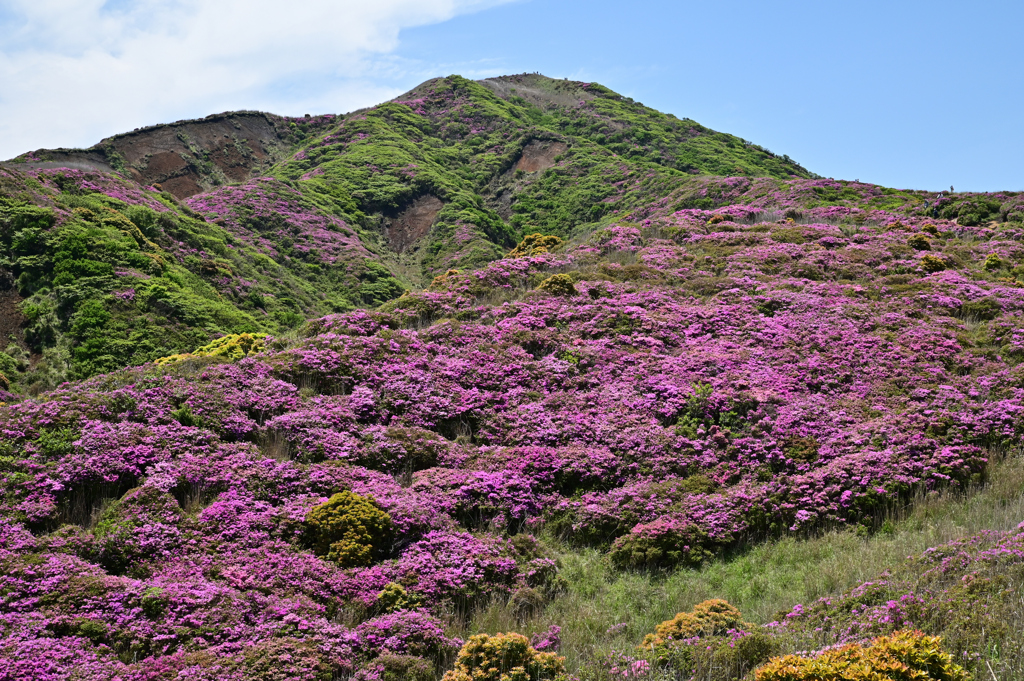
[0, 75, 819, 392]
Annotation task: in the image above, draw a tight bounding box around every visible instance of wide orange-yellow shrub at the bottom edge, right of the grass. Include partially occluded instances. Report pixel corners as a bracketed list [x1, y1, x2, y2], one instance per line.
[754, 631, 971, 681]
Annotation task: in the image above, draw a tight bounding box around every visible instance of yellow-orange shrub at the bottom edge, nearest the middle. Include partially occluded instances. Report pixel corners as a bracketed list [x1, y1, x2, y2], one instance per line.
[441, 632, 566, 681]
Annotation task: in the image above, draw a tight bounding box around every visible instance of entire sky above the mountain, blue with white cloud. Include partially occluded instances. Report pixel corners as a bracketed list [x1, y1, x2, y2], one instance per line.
[0, 0, 1024, 190]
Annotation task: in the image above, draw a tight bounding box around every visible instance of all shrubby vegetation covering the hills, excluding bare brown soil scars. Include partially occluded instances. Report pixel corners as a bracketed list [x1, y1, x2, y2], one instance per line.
[6, 73, 1024, 681]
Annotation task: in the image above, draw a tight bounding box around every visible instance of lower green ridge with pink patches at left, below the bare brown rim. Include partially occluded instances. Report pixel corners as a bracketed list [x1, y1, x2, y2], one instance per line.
[0, 164, 402, 393]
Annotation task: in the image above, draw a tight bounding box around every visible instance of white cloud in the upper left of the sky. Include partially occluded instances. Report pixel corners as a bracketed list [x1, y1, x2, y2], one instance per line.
[0, 0, 506, 159]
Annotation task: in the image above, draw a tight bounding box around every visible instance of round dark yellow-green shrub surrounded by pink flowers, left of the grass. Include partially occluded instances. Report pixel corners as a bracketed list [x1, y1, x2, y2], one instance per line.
[306, 492, 394, 567]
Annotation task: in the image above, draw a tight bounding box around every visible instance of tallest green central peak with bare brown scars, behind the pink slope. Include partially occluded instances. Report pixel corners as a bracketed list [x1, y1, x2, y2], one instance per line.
[266, 75, 809, 279]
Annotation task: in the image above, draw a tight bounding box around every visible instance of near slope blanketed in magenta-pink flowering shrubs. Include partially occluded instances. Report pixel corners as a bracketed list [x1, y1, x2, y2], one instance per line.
[0, 178, 1024, 679]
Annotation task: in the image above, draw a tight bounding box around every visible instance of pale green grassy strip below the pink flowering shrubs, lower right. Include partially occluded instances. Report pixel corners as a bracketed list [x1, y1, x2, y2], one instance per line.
[453, 446, 1024, 678]
